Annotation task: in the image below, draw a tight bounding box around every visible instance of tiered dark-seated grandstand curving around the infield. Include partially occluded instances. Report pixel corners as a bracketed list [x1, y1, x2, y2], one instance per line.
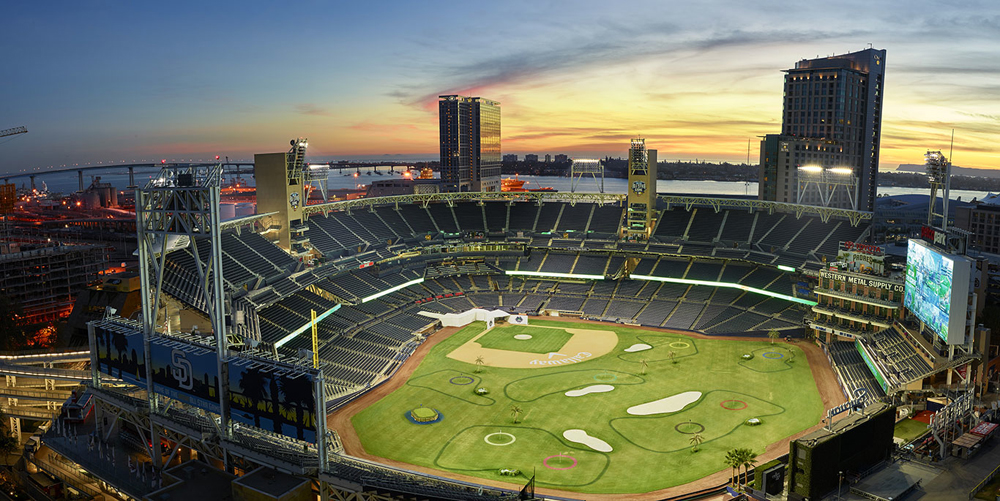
[143, 196, 865, 406]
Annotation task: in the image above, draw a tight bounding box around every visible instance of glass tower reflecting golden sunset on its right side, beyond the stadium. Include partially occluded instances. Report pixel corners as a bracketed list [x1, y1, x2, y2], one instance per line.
[438, 95, 501, 191]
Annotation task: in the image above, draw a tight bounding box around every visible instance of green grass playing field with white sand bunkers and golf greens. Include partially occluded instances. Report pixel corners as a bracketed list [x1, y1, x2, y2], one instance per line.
[352, 318, 824, 494]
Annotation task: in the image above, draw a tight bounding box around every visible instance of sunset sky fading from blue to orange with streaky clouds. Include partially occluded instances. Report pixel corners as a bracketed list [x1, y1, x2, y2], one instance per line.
[0, 0, 1000, 173]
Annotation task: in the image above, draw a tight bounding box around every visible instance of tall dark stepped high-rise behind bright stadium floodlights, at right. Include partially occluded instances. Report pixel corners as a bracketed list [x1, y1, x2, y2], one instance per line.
[759, 49, 885, 211]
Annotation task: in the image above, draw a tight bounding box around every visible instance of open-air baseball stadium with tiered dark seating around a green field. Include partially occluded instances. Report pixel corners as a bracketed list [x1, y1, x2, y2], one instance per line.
[41, 140, 900, 499]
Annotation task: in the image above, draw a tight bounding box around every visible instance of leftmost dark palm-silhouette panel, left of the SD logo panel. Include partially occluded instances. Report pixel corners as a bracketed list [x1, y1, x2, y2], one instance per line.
[94, 325, 146, 386]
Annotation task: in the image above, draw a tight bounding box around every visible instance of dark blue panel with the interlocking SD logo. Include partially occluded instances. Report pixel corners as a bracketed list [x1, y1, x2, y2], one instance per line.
[150, 338, 220, 414]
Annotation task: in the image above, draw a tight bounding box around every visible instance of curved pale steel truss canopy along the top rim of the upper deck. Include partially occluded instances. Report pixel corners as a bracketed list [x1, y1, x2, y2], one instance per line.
[302, 192, 872, 226]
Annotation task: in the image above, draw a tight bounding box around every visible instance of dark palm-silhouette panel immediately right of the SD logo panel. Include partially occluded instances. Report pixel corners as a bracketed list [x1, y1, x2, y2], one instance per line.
[229, 358, 317, 443]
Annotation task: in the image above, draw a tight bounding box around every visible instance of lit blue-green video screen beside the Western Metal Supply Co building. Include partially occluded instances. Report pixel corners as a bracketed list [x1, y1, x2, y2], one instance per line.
[903, 238, 971, 344]
